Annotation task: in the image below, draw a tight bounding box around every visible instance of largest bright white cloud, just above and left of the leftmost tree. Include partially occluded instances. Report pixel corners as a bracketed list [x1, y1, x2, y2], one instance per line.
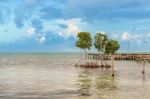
[42, 18, 82, 38]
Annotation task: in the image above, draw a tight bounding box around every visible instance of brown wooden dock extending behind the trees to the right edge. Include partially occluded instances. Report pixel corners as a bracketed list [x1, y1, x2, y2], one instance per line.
[88, 53, 150, 61]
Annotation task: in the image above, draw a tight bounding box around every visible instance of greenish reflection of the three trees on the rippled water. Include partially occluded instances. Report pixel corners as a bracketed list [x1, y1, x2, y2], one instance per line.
[76, 69, 117, 99]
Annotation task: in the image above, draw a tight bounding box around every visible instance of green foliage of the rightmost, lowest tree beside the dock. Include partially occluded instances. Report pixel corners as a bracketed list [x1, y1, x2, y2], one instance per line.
[105, 40, 120, 54]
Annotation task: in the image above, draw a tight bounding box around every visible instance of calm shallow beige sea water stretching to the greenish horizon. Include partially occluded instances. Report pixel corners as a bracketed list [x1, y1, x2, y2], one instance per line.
[0, 53, 150, 99]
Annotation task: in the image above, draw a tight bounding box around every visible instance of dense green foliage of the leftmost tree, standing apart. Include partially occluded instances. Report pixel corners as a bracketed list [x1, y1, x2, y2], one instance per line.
[76, 32, 92, 49]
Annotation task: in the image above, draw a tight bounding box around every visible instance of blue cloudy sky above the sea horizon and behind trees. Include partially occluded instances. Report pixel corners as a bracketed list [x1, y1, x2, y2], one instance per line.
[0, 0, 150, 52]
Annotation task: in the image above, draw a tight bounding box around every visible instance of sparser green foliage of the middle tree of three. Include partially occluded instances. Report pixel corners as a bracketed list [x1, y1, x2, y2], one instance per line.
[94, 33, 108, 51]
